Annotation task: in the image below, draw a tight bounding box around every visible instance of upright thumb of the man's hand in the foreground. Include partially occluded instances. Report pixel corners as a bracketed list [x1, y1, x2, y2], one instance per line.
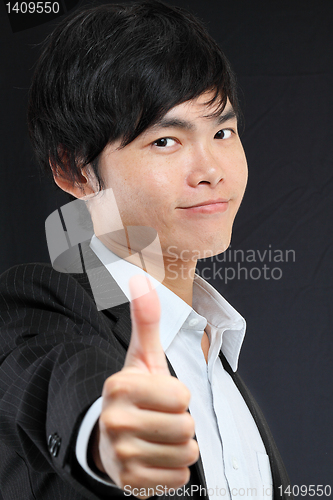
[124, 275, 170, 375]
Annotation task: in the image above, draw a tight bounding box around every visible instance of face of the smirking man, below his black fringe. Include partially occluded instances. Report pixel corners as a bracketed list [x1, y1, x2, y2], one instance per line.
[91, 94, 247, 258]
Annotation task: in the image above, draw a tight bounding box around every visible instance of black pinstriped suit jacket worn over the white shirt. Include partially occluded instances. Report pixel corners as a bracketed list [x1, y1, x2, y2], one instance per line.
[0, 258, 290, 500]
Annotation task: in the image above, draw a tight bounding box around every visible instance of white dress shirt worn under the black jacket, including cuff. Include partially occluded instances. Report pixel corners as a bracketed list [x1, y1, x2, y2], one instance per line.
[76, 236, 272, 500]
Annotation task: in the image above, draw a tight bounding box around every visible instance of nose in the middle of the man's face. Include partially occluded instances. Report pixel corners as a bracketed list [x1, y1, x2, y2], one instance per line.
[187, 145, 225, 187]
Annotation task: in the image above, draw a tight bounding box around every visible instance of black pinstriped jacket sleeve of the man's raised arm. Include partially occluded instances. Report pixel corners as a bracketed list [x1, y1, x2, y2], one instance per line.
[0, 264, 125, 499]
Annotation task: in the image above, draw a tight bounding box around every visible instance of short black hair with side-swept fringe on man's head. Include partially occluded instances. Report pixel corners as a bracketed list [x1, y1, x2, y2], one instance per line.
[28, 0, 238, 187]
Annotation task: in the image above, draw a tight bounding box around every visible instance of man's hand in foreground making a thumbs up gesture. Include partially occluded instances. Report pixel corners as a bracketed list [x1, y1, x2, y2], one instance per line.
[93, 276, 199, 498]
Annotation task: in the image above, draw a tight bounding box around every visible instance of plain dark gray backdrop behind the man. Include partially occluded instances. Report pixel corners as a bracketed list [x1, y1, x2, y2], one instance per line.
[0, 0, 333, 498]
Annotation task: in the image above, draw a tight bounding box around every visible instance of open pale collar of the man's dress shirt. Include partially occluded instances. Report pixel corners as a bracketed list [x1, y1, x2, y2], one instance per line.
[90, 235, 246, 371]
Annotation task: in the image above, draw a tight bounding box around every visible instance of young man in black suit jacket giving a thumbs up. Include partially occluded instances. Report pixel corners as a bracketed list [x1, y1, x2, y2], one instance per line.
[0, 1, 289, 500]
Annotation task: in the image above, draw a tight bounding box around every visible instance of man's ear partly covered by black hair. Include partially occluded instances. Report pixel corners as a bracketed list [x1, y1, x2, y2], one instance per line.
[50, 162, 99, 198]
